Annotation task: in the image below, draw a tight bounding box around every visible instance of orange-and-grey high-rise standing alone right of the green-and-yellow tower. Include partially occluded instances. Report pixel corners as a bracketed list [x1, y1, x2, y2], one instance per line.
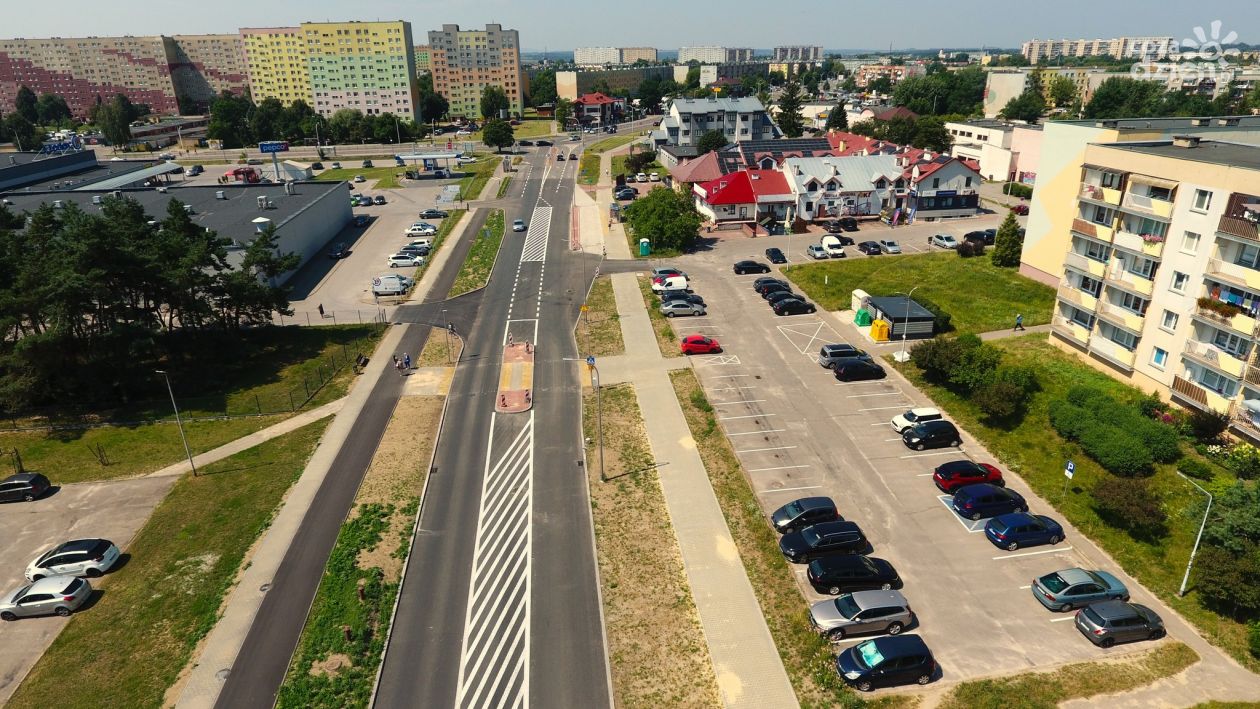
[428, 24, 525, 118]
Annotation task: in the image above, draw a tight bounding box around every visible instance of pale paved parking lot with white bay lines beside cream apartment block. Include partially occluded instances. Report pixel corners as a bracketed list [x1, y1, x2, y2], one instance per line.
[670, 235, 1187, 681]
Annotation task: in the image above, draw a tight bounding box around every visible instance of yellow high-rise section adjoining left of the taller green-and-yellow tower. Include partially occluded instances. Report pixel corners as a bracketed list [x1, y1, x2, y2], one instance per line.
[241, 26, 314, 107]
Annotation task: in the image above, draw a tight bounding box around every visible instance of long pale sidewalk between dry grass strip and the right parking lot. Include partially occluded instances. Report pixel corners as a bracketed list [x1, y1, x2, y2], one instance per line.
[601, 273, 799, 709]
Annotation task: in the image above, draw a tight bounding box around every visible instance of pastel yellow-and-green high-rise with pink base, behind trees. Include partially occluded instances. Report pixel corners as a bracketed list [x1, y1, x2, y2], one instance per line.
[300, 20, 418, 120]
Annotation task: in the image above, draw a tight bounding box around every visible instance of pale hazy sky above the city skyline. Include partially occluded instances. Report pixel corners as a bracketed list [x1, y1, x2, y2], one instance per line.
[0, 0, 1260, 52]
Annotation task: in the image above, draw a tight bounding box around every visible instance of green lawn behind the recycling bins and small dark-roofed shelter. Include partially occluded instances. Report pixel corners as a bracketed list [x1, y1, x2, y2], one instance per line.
[784, 252, 1055, 332]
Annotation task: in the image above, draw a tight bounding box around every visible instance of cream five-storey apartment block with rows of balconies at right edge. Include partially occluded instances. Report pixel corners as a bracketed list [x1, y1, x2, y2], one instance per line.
[1051, 135, 1260, 440]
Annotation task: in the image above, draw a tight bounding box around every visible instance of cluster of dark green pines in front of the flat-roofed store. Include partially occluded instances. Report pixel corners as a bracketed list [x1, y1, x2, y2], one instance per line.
[0, 196, 300, 412]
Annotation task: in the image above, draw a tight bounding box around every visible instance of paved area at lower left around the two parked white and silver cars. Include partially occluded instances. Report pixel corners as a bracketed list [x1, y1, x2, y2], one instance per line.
[0, 477, 176, 704]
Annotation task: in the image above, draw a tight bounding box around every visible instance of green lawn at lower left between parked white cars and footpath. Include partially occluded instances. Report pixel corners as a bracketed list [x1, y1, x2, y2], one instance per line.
[8, 419, 326, 709]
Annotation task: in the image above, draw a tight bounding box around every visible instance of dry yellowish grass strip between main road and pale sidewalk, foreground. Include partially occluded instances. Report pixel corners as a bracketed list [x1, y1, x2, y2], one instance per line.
[582, 384, 721, 706]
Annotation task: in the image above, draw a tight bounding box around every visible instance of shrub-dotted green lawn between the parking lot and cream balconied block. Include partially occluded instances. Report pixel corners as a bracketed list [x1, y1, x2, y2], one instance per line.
[890, 335, 1260, 671]
